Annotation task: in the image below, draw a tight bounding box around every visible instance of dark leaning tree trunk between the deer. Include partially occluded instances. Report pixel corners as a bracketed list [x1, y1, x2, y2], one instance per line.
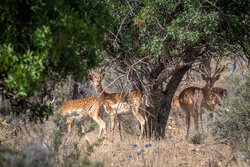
[149, 66, 191, 139]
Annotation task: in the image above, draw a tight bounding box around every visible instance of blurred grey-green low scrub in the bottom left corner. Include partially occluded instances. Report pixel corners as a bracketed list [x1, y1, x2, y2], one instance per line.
[0, 141, 102, 167]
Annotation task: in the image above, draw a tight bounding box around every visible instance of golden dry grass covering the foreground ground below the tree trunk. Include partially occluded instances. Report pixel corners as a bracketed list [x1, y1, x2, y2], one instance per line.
[85, 111, 239, 167]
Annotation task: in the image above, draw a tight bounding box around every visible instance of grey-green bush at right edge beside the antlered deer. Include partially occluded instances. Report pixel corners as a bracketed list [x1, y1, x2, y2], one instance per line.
[211, 72, 250, 149]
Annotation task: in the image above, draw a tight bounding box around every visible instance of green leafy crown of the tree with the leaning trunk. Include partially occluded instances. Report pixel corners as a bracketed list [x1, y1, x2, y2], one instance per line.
[106, 0, 249, 62]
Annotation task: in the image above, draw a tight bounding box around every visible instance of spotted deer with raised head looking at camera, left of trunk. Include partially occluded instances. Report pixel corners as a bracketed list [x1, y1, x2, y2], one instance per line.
[89, 75, 147, 141]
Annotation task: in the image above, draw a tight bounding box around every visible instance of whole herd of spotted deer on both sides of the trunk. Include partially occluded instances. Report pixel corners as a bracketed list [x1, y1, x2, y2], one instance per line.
[57, 60, 228, 141]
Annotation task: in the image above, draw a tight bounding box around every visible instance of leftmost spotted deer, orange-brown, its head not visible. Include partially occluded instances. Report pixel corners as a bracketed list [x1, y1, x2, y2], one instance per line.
[57, 93, 106, 138]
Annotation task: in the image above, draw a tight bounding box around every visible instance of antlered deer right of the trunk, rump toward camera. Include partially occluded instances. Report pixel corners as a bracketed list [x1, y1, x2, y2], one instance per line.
[177, 60, 225, 138]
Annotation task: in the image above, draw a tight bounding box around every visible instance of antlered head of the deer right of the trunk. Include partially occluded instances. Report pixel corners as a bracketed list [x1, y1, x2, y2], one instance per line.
[200, 59, 225, 89]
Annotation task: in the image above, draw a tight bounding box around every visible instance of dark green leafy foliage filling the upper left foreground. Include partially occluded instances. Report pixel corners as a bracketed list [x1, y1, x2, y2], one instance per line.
[0, 0, 112, 119]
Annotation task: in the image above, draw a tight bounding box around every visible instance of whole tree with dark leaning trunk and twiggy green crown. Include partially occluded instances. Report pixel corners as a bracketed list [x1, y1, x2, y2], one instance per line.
[105, 0, 249, 138]
